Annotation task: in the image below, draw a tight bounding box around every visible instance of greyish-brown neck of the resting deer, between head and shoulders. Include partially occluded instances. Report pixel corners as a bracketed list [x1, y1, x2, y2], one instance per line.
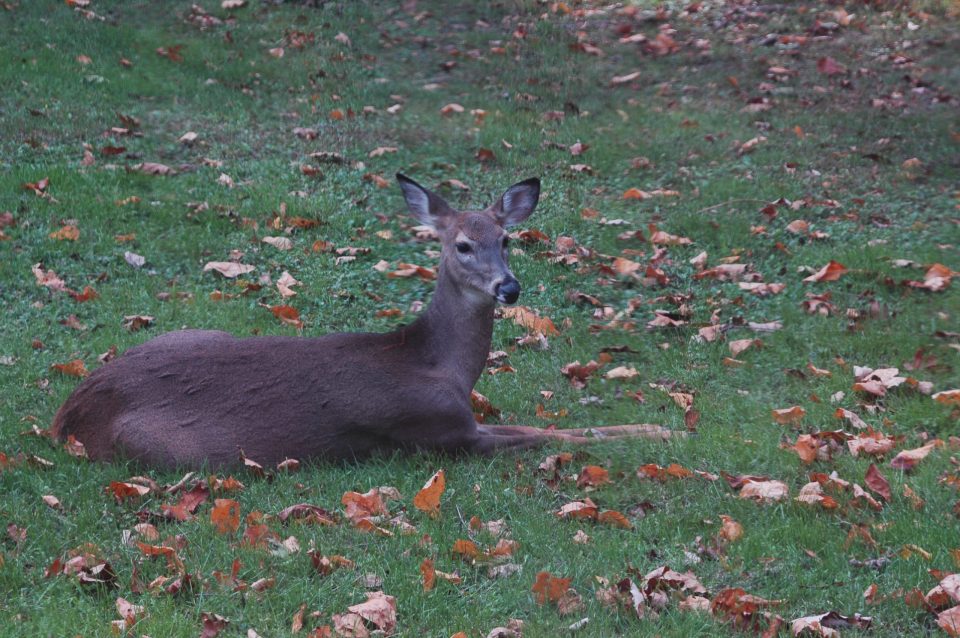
[406, 268, 495, 394]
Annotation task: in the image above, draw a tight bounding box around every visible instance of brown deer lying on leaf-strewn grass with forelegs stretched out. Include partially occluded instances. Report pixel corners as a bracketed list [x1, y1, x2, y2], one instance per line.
[51, 174, 671, 469]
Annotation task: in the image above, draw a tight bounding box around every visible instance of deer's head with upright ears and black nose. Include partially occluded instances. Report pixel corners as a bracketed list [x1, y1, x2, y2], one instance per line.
[397, 174, 540, 304]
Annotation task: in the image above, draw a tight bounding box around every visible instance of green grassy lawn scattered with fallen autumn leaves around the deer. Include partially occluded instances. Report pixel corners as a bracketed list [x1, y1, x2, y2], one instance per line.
[0, 0, 960, 638]
